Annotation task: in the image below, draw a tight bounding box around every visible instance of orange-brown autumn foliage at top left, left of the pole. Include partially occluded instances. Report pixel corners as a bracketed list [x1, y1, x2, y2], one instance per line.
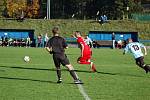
[6, 0, 40, 18]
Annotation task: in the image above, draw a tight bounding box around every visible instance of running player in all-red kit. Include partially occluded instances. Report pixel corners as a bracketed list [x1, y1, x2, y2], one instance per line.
[74, 31, 96, 72]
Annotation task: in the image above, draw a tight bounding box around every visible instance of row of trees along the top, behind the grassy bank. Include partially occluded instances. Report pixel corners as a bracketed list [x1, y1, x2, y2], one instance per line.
[0, 0, 145, 19]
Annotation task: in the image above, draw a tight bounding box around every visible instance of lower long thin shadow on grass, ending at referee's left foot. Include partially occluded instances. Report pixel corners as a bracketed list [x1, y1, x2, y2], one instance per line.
[0, 77, 56, 84]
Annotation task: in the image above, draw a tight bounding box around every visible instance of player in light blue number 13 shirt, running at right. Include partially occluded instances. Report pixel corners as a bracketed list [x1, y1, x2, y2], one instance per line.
[123, 38, 150, 73]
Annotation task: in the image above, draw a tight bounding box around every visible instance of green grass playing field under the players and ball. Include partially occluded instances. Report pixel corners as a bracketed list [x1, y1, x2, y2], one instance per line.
[0, 47, 150, 100]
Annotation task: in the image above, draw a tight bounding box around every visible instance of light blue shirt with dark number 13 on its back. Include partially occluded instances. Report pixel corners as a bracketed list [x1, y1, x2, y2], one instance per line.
[124, 42, 144, 59]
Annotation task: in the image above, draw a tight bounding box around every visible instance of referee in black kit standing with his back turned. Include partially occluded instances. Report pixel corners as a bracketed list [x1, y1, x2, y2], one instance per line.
[46, 27, 82, 84]
